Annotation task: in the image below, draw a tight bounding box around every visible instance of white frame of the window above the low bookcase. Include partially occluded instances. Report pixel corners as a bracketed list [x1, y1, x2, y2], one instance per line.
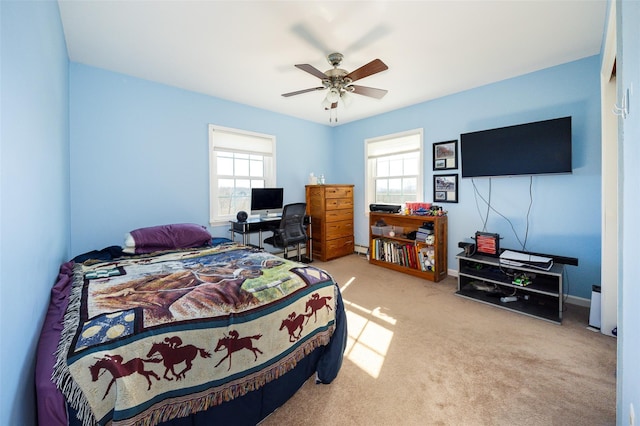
[364, 128, 425, 216]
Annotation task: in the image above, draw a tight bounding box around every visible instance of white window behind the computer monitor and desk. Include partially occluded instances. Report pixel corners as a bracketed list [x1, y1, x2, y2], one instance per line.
[209, 124, 276, 224]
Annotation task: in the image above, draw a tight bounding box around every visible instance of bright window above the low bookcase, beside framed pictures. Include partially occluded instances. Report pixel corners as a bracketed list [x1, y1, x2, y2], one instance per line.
[365, 129, 424, 212]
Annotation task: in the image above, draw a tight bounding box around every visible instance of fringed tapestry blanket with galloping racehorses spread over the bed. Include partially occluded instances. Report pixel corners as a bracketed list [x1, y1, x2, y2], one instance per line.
[54, 243, 339, 425]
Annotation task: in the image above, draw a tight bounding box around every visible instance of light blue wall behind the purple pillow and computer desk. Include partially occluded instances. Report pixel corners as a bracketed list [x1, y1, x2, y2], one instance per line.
[70, 63, 331, 256]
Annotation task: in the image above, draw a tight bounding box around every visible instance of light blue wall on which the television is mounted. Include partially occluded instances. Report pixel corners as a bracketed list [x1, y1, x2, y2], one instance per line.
[334, 56, 601, 298]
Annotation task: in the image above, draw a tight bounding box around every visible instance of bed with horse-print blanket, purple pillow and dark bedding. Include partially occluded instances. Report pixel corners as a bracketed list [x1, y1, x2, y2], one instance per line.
[36, 224, 346, 425]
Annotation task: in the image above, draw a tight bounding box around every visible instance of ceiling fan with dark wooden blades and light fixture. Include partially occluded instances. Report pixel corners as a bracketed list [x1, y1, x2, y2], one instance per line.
[282, 52, 389, 117]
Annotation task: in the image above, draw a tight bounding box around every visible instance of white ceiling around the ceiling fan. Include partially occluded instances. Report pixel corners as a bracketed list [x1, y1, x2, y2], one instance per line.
[59, 0, 606, 125]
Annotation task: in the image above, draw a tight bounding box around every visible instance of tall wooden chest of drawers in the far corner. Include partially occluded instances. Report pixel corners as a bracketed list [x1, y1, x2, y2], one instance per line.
[306, 185, 355, 262]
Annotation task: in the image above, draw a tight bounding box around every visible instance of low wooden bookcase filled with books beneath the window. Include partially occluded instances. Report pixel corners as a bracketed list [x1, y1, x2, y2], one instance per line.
[369, 212, 447, 282]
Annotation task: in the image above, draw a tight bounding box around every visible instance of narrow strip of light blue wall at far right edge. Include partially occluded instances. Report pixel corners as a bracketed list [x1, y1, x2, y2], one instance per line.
[616, 1, 640, 425]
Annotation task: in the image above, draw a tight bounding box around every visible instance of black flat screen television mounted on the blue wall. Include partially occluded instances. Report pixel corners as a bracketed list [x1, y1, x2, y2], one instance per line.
[460, 117, 572, 178]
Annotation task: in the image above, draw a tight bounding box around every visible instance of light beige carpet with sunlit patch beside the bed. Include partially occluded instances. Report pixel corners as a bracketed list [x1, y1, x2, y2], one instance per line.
[262, 255, 616, 426]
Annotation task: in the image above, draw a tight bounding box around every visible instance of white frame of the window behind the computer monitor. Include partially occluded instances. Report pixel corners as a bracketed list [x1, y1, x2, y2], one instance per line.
[208, 124, 277, 226]
